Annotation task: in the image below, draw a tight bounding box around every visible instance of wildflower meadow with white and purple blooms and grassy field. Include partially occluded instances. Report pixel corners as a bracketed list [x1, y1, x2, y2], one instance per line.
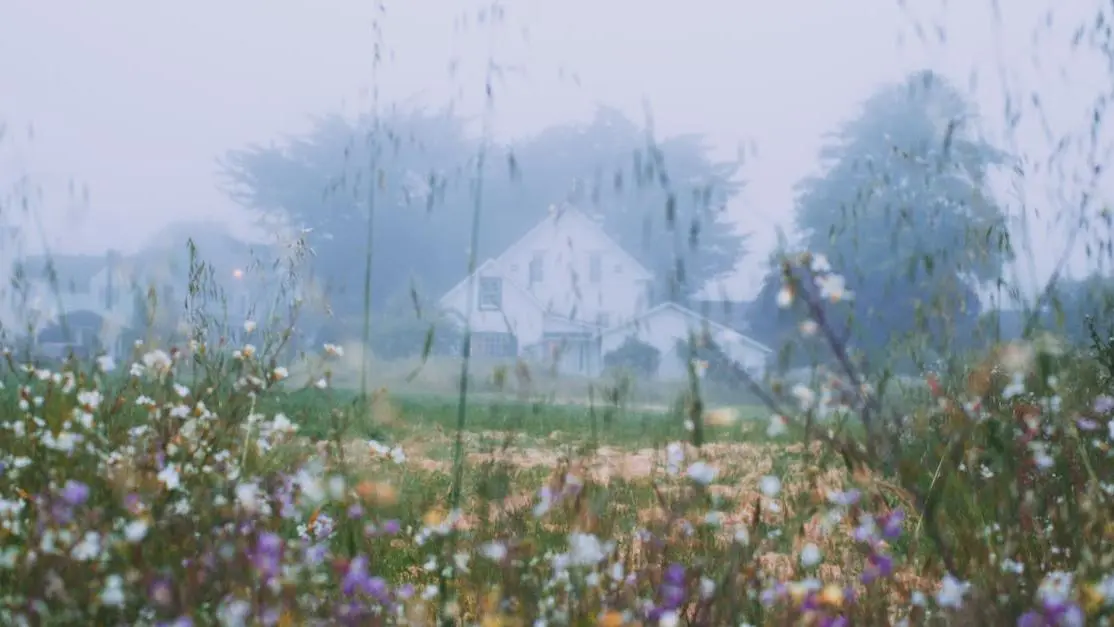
[0, 250, 1114, 627]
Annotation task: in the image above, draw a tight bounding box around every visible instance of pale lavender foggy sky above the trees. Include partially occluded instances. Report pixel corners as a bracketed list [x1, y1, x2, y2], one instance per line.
[0, 0, 1114, 305]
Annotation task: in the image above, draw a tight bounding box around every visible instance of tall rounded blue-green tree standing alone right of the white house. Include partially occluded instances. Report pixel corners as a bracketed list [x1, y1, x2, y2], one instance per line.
[755, 71, 1013, 369]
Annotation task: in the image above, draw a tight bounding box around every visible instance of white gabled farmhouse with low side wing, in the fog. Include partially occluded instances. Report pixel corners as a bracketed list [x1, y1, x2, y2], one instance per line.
[440, 207, 770, 376]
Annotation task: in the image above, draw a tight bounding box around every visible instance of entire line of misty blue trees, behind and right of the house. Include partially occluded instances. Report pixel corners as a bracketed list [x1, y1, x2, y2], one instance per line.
[223, 71, 1108, 365]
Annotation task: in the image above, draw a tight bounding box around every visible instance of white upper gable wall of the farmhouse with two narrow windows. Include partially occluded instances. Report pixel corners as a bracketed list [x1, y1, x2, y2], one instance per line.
[498, 212, 651, 326]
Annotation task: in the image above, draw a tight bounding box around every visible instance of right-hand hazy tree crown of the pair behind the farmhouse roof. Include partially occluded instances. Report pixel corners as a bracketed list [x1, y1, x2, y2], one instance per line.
[491, 108, 746, 301]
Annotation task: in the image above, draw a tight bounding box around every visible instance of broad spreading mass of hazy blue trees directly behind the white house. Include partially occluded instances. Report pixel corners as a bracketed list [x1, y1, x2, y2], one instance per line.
[224, 109, 743, 314]
